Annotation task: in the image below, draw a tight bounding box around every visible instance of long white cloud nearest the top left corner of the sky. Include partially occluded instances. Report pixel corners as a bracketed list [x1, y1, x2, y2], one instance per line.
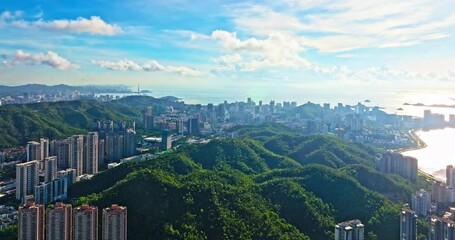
[0, 11, 122, 36]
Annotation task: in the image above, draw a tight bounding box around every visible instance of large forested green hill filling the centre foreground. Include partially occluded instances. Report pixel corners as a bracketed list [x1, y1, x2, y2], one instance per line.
[69, 125, 432, 239]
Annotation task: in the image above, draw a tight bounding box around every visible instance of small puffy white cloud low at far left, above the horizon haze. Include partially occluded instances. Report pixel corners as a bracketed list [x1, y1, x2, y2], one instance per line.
[3, 50, 78, 70]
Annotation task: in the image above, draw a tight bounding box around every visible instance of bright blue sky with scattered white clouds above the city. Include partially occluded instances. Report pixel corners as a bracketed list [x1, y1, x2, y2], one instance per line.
[0, 0, 455, 101]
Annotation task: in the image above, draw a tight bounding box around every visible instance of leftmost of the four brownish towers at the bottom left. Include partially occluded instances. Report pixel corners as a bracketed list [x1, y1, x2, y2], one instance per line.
[18, 201, 44, 240]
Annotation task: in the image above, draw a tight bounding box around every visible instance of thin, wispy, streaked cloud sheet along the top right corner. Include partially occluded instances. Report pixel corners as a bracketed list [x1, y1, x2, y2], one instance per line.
[229, 0, 455, 52]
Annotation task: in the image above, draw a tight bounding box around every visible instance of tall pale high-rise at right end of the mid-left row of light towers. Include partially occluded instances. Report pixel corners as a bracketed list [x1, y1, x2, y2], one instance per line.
[82, 132, 98, 174]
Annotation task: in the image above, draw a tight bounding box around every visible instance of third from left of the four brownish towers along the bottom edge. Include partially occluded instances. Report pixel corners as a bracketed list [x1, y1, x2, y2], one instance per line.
[73, 205, 98, 240]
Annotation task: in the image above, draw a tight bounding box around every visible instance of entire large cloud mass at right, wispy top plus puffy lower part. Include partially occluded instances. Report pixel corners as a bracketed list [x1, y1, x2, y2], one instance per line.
[198, 0, 455, 82]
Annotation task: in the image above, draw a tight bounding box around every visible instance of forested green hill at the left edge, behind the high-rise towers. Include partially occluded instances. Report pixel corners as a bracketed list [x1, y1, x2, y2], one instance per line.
[0, 96, 178, 149]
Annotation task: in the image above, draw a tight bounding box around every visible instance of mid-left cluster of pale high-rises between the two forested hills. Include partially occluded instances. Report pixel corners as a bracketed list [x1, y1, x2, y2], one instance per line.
[16, 121, 137, 204]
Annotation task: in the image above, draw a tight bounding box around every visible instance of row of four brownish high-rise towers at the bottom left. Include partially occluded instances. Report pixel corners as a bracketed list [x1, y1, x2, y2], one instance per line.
[18, 201, 127, 240]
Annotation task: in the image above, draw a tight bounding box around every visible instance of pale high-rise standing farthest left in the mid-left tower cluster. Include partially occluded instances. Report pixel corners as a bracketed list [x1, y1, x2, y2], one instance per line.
[16, 160, 39, 204]
